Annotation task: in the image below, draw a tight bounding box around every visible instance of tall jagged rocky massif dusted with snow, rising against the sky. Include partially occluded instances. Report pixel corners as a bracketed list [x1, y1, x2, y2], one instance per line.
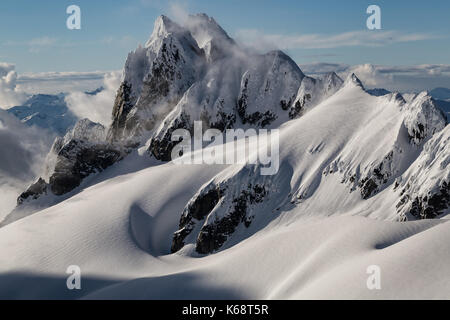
[109, 14, 342, 161]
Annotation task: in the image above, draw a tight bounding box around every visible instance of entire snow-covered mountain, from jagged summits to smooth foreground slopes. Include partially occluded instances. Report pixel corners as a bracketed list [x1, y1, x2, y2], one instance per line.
[0, 14, 450, 300]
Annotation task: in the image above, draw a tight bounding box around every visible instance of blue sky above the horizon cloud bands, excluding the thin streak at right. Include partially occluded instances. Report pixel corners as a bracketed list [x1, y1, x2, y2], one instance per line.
[0, 0, 450, 73]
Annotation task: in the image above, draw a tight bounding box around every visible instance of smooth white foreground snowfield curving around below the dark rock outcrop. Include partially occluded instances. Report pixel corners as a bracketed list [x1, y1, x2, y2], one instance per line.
[0, 156, 450, 299]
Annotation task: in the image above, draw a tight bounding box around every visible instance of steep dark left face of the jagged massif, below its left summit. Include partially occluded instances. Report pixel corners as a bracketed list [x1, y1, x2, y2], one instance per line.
[109, 16, 204, 141]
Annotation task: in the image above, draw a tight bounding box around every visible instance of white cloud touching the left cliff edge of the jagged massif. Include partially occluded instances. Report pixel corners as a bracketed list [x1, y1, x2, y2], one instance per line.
[66, 71, 121, 126]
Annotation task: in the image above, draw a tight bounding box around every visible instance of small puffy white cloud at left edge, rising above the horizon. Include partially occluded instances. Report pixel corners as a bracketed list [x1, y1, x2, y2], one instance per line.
[0, 62, 26, 108]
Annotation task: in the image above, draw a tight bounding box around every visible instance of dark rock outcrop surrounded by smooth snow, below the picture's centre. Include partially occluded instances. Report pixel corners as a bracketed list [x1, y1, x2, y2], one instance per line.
[171, 165, 292, 254]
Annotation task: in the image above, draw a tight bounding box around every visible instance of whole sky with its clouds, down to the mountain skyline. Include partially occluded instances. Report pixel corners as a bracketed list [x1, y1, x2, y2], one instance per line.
[0, 0, 450, 91]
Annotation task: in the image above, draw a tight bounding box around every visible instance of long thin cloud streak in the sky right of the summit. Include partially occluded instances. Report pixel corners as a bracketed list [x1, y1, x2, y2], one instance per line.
[236, 29, 438, 50]
